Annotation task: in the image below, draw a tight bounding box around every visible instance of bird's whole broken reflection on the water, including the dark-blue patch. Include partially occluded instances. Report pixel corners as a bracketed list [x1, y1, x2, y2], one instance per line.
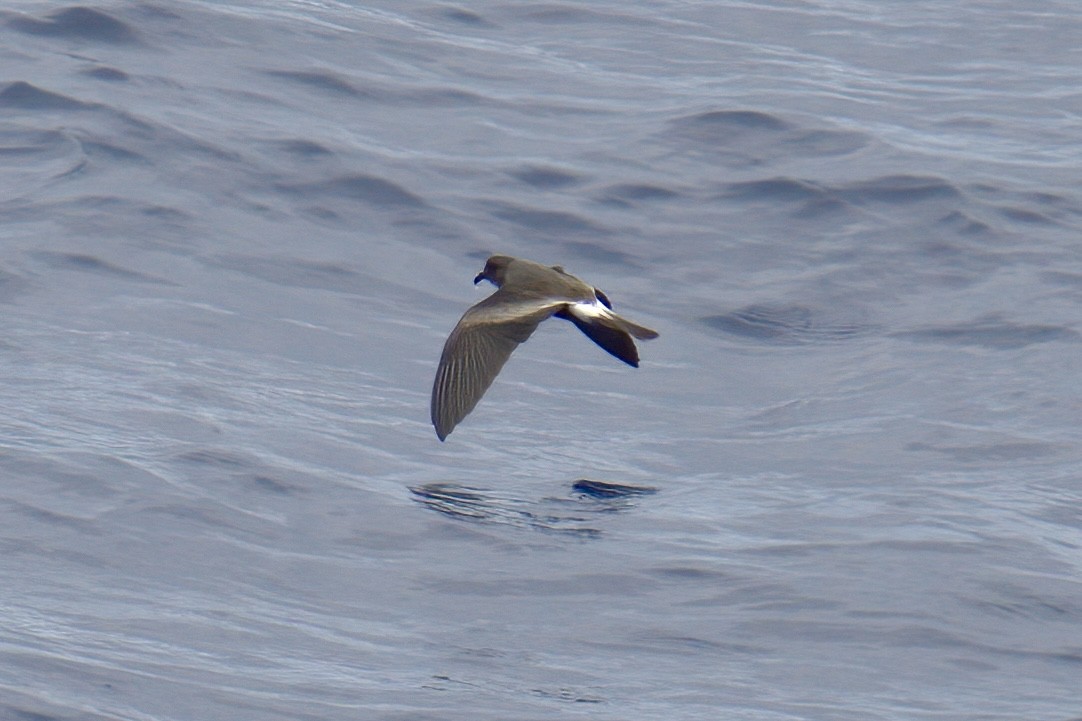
[410, 480, 657, 538]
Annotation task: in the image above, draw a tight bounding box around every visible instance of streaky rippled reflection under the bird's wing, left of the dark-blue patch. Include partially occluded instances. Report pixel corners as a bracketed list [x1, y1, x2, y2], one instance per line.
[410, 483, 602, 538]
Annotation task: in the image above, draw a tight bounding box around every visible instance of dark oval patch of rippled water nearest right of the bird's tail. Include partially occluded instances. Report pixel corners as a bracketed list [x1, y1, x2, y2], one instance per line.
[701, 304, 874, 345]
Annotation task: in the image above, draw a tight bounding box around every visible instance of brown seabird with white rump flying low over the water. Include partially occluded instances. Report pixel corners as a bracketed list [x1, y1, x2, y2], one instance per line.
[432, 255, 658, 441]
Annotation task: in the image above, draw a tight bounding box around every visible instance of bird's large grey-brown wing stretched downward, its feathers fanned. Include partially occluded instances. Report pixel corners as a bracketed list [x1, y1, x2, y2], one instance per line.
[432, 290, 563, 441]
